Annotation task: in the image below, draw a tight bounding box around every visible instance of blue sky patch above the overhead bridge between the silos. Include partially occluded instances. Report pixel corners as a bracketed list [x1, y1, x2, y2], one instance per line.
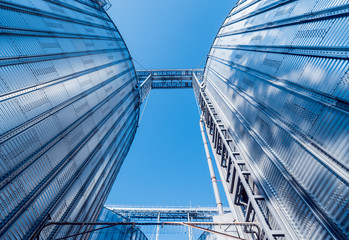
[108, 0, 236, 68]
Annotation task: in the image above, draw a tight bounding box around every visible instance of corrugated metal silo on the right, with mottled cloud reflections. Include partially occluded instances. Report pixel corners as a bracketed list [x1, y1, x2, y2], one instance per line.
[204, 0, 349, 239]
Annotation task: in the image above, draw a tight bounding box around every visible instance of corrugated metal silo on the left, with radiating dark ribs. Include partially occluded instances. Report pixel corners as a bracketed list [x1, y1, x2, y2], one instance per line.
[0, 0, 139, 239]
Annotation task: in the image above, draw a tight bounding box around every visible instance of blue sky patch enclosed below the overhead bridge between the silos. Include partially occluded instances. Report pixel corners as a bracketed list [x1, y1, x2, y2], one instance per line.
[107, 89, 215, 206]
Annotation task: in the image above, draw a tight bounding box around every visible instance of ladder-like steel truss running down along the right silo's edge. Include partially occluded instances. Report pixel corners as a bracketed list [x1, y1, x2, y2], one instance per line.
[193, 75, 286, 239]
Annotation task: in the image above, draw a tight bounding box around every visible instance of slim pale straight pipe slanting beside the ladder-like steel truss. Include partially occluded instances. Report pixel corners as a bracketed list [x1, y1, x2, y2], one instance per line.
[200, 117, 224, 215]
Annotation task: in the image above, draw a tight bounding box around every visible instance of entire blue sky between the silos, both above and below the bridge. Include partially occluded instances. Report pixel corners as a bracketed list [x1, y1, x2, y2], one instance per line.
[106, 0, 235, 209]
